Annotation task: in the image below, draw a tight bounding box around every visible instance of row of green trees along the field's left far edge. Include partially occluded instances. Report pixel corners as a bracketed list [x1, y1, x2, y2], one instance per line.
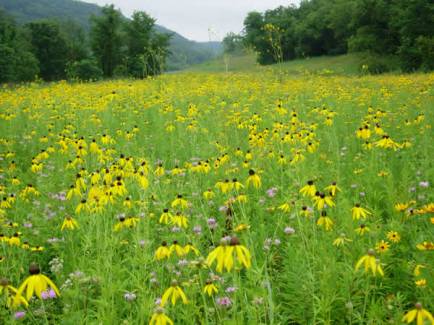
[0, 5, 170, 82]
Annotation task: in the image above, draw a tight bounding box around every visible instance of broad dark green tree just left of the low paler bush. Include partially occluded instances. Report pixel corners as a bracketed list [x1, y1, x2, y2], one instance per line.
[26, 20, 68, 80]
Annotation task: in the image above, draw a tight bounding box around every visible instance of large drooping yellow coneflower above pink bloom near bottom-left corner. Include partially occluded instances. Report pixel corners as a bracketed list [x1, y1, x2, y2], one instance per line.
[17, 264, 60, 301]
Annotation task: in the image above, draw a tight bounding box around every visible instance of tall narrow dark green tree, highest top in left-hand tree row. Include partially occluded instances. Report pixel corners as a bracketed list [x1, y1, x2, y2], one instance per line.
[91, 5, 122, 77]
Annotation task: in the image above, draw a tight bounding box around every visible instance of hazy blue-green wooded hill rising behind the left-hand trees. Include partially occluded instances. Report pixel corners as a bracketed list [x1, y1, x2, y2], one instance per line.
[0, 0, 222, 70]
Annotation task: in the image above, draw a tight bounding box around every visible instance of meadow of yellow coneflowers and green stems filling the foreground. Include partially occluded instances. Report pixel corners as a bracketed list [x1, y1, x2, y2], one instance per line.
[0, 70, 434, 325]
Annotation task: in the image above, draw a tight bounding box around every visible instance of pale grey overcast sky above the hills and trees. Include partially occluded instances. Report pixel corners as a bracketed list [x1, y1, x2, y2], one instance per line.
[85, 0, 299, 41]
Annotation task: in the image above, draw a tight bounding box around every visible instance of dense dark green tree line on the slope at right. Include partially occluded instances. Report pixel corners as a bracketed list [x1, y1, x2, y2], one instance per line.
[223, 0, 434, 71]
